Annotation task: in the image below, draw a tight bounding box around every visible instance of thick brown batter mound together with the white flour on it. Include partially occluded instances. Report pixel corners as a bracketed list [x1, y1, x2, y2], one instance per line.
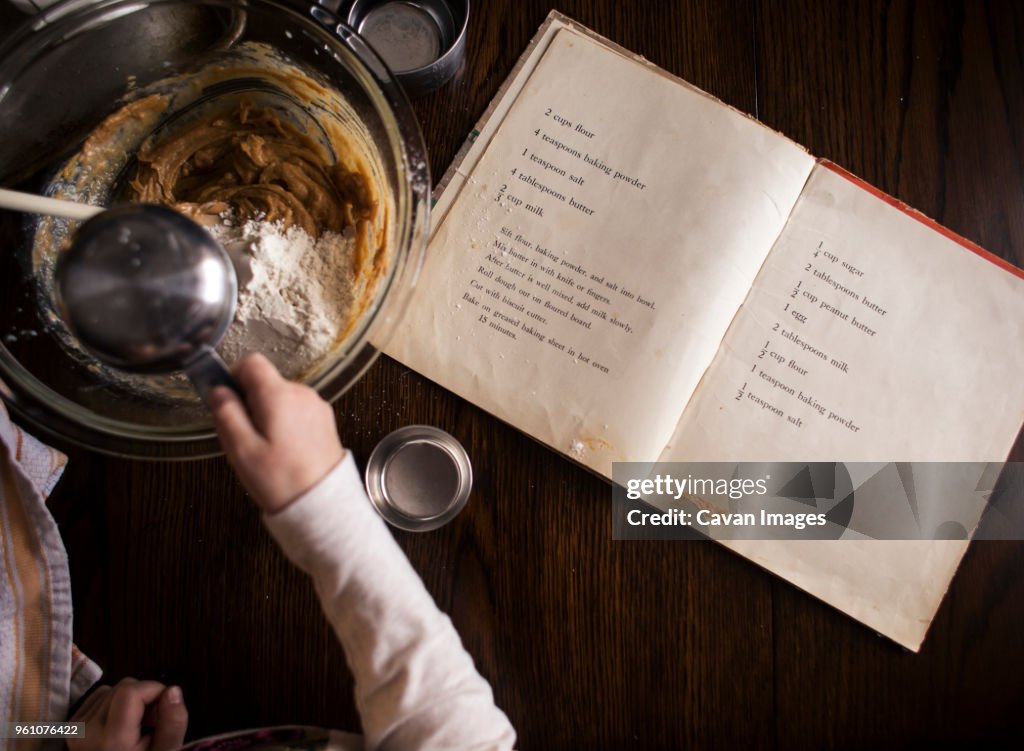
[126, 99, 377, 377]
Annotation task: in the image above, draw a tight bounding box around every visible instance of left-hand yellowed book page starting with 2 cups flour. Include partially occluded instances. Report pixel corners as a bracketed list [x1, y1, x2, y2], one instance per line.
[386, 29, 813, 476]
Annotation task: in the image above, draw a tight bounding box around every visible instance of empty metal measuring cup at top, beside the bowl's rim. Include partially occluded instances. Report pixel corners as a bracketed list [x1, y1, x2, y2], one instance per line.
[347, 0, 469, 96]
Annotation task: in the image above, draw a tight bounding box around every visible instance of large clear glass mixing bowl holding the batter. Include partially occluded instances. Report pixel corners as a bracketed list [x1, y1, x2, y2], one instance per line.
[0, 0, 430, 458]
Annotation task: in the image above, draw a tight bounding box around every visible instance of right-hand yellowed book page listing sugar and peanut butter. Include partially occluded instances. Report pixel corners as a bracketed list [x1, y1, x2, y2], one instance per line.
[662, 162, 1024, 651]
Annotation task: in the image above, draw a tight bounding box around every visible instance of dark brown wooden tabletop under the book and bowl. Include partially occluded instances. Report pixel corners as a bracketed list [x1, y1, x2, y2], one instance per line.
[0, 0, 1024, 749]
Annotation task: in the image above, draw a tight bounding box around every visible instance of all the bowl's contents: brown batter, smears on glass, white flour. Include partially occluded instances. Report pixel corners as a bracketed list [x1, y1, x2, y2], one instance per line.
[34, 44, 392, 388]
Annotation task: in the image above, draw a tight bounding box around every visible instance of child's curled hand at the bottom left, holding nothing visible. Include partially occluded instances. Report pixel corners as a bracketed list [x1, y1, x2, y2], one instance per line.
[68, 678, 188, 751]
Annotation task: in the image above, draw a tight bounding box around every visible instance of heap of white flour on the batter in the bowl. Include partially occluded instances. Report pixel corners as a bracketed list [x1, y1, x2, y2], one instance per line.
[209, 215, 355, 378]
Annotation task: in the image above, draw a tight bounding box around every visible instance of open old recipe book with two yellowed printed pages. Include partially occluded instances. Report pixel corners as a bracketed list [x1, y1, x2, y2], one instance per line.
[386, 13, 1024, 650]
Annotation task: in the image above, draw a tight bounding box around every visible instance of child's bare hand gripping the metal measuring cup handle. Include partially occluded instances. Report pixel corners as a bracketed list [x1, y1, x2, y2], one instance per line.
[211, 354, 344, 513]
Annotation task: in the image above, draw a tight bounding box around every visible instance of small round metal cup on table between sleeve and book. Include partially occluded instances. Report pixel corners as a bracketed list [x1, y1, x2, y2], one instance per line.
[366, 425, 473, 532]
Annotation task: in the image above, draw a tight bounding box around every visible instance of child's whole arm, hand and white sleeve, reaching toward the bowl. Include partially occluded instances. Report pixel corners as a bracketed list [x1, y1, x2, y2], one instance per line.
[214, 357, 515, 749]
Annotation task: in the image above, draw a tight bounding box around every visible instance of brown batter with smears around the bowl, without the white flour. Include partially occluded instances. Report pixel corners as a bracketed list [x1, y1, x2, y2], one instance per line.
[33, 43, 394, 399]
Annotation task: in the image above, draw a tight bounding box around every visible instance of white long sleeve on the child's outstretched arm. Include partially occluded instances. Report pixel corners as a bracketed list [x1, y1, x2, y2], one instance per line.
[263, 453, 515, 749]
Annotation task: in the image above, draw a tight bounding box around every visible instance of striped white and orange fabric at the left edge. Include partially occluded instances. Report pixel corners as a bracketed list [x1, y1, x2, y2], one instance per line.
[0, 403, 100, 749]
